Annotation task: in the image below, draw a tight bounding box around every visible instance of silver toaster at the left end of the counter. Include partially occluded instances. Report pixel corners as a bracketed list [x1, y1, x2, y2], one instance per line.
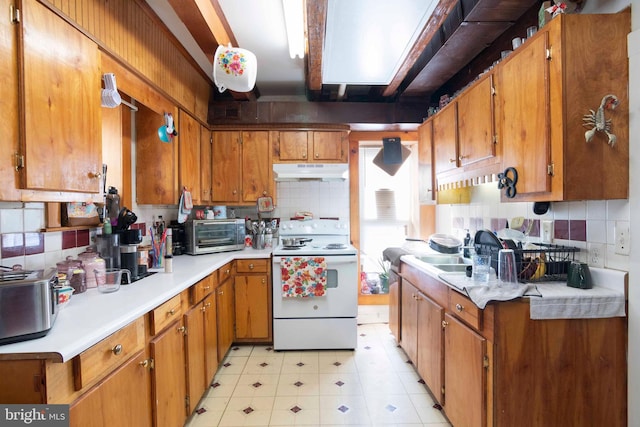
[0, 269, 58, 344]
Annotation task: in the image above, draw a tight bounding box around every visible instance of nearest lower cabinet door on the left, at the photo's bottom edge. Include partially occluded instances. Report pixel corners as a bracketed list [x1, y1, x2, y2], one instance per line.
[69, 352, 151, 427]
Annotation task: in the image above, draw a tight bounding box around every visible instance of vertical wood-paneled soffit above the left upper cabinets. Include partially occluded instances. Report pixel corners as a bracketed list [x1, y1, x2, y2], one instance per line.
[45, 0, 212, 123]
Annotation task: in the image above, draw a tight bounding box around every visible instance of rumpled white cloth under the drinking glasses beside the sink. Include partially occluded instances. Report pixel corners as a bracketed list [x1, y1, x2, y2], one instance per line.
[439, 273, 540, 309]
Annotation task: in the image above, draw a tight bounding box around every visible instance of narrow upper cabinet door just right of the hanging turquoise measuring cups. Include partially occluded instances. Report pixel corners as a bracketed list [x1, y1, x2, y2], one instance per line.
[178, 110, 202, 204]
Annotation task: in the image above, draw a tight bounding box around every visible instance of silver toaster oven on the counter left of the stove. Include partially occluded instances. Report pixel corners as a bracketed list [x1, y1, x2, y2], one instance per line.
[185, 218, 245, 255]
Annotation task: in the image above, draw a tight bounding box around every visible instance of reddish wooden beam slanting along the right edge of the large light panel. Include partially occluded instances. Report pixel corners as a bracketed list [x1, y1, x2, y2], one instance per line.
[382, 0, 458, 96]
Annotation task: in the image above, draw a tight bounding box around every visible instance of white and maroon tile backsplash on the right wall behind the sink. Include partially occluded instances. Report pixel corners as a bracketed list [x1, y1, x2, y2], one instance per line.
[436, 183, 630, 271]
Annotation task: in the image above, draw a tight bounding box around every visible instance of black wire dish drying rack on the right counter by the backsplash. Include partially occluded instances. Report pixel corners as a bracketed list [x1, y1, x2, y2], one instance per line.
[476, 243, 580, 283]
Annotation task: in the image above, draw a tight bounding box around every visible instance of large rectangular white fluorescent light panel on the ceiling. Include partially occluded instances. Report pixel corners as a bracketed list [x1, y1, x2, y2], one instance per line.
[322, 0, 438, 85]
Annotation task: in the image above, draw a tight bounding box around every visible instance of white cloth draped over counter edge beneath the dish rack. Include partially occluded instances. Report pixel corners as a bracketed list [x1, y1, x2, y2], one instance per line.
[530, 282, 626, 319]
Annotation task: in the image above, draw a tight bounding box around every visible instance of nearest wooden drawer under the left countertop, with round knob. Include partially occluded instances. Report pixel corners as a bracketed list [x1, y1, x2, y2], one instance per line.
[73, 317, 144, 390]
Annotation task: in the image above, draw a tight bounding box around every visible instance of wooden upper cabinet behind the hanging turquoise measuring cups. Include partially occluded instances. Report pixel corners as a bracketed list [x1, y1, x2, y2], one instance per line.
[136, 105, 181, 205]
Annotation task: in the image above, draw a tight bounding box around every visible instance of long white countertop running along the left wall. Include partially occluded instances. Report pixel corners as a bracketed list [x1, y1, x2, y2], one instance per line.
[0, 248, 271, 362]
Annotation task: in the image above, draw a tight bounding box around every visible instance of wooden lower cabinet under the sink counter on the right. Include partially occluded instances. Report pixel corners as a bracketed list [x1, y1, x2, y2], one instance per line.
[395, 263, 627, 427]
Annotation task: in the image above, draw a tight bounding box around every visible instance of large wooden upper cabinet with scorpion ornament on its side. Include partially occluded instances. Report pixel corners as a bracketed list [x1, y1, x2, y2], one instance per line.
[496, 10, 630, 201]
